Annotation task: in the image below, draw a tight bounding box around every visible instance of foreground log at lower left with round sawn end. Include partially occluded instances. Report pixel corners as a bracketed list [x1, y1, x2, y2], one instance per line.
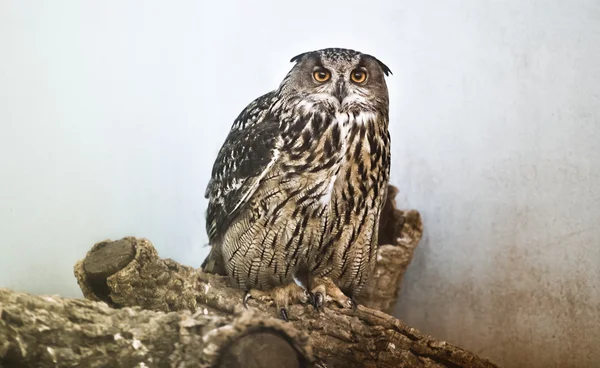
[0, 289, 312, 367]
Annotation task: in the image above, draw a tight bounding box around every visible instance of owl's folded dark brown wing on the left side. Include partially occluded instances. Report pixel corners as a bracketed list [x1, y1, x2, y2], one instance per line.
[205, 92, 280, 244]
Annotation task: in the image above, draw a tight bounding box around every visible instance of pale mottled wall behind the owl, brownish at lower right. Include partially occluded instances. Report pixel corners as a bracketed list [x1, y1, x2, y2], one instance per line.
[0, 0, 600, 367]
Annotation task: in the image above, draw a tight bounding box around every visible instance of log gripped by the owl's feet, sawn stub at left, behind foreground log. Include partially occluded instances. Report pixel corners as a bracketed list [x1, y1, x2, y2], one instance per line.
[68, 238, 493, 367]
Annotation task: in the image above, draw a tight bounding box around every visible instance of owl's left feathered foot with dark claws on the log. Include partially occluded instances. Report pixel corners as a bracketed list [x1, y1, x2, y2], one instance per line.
[244, 282, 314, 322]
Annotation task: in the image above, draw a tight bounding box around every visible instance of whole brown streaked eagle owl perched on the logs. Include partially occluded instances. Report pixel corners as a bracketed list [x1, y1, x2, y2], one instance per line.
[202, 48, 391, 319]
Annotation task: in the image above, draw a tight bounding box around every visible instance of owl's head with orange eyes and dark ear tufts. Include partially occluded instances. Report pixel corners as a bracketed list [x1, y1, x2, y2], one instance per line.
[280, 48, 392, 110]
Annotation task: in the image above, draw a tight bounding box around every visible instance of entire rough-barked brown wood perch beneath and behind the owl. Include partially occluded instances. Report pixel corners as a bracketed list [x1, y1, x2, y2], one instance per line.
[0, 187, 494, 367]
